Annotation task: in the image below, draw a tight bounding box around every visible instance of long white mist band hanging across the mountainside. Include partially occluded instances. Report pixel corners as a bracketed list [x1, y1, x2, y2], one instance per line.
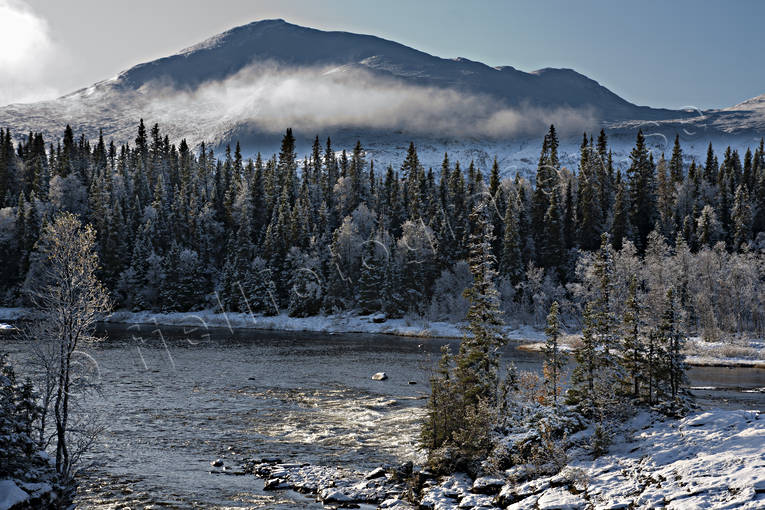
[141, 64, 597, 138]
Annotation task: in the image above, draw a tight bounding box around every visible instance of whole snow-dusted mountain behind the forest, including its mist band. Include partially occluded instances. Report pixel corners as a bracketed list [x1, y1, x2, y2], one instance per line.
[0, 20, 765, 173]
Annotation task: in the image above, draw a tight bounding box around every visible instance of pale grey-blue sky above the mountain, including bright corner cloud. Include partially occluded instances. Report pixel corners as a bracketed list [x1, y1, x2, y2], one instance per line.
[0, 0, 765, 109]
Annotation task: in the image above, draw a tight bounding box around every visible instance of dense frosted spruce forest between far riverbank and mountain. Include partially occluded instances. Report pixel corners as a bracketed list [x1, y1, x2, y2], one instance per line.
[0, 121, 765, 334]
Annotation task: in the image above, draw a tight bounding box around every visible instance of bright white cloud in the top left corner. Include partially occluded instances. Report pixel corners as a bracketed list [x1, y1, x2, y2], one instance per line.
[0, 0, 58, 105]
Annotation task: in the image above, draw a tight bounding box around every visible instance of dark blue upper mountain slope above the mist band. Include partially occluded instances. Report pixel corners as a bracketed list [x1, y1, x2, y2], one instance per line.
[109, 20, 677, 120]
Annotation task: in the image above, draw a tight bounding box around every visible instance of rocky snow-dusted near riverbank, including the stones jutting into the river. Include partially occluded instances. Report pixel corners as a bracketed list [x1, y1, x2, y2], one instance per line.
[232, 409, 765, 510]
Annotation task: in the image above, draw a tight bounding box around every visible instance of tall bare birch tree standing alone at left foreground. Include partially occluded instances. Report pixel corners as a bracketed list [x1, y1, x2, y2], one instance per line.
[29, 213, 111, 478]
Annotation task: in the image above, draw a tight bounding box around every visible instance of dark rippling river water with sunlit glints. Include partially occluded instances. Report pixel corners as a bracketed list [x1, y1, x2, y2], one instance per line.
[4, 326, 765, 509]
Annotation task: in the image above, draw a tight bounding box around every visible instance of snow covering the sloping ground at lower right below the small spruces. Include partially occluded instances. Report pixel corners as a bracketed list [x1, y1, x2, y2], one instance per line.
[422, 409, 765, 510]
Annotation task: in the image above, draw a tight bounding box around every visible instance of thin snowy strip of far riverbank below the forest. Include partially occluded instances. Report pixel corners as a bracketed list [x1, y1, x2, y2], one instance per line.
[0, 308, 765, 369]
